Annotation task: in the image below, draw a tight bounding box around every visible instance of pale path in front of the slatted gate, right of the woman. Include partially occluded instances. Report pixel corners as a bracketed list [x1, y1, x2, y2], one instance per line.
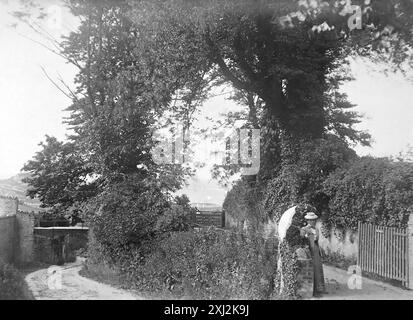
[315, 266, 413, 300]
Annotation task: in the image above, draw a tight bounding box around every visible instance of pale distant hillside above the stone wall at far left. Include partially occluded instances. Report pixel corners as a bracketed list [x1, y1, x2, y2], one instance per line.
[0, 173, 44, 212]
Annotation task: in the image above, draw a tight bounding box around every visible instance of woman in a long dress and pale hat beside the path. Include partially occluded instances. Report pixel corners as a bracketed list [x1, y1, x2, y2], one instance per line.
[300, 212, 326, 297]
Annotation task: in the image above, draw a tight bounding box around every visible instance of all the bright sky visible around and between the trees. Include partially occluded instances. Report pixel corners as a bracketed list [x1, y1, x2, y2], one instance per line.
[0, 0, 413, 203]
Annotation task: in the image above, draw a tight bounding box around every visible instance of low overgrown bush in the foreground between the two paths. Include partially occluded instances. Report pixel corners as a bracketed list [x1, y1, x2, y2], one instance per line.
[89, 229, 276, 299]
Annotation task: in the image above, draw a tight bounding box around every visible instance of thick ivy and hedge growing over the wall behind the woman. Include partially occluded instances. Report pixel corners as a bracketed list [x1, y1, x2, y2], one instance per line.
[225, 148, 413, 234]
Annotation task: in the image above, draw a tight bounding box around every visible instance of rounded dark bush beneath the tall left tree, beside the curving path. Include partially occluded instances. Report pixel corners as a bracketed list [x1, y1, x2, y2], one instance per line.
[86, 179, 169, 251]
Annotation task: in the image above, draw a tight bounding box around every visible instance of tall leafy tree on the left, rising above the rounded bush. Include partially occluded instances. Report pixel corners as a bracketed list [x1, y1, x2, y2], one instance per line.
[23, 1, 195, 219]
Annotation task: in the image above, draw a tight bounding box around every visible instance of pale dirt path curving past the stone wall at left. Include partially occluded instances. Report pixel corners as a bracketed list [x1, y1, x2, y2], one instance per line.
[26, 260, 143, 300]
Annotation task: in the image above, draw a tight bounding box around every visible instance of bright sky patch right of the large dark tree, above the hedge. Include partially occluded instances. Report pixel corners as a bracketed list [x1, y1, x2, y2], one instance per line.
[343, 61, 413, 157]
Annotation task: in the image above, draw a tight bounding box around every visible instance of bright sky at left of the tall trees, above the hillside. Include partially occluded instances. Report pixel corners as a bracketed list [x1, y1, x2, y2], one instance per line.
[0, 0, 76, 178]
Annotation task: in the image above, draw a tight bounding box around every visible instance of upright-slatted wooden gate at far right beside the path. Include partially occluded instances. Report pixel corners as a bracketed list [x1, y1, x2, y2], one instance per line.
[358, 222, 409, 286]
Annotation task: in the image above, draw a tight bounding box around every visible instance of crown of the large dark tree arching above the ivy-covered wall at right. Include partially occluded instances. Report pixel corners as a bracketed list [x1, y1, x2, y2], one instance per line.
[124, 0, 412, 182]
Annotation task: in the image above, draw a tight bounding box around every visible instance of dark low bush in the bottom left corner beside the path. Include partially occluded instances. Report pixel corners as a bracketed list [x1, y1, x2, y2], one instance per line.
[0, 261, 33, 300]
